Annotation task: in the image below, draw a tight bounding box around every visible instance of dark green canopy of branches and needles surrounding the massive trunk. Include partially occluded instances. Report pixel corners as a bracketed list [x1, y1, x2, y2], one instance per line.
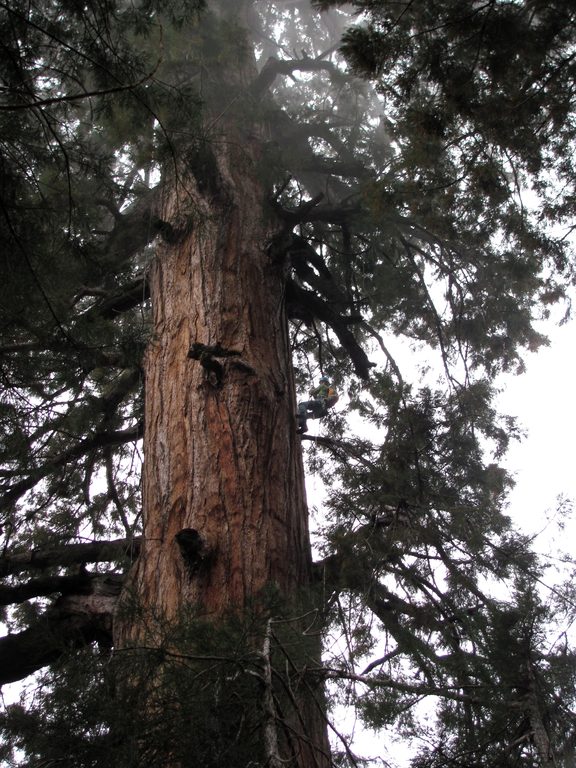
[0, 0, 576, 768]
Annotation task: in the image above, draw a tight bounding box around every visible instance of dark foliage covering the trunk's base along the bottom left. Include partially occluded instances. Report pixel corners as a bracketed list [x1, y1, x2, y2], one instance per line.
[0, 600, 326, 768]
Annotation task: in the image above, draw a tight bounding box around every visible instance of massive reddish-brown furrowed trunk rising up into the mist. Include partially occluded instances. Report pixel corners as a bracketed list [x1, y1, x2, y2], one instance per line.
[115, 9, 329, 768]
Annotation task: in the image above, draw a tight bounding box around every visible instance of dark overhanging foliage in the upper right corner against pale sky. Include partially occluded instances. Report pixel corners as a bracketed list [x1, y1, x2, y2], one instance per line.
[310, 0, 574, 370]
